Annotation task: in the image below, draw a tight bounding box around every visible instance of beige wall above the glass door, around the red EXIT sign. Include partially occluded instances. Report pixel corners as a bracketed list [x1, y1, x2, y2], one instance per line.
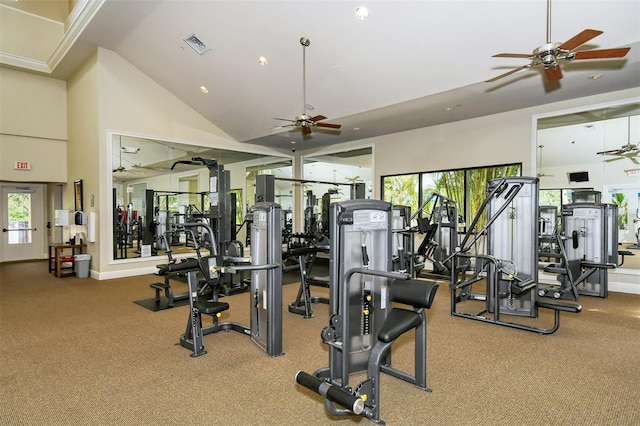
[0, 68, 67, 182]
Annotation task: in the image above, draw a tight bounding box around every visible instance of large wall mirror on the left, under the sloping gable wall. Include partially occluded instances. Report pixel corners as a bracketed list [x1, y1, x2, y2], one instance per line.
[110, 133, 293, 261]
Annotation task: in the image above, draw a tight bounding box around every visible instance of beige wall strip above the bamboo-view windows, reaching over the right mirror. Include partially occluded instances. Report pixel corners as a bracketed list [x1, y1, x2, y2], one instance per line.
[368, 88, 640, 198]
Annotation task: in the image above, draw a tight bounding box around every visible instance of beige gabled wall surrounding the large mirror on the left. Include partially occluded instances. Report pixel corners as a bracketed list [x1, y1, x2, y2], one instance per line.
[84, 49, 276, 278]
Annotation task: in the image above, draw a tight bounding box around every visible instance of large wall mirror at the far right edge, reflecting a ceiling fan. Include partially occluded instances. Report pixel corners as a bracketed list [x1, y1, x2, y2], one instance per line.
[535, 99, 640, 269]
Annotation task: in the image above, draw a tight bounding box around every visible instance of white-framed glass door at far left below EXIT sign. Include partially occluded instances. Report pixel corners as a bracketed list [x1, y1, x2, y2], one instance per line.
[0, 185, 44, 261]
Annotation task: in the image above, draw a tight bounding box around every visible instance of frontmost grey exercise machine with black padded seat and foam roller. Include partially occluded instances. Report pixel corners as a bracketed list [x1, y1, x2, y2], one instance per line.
[296, 200, 438, 424]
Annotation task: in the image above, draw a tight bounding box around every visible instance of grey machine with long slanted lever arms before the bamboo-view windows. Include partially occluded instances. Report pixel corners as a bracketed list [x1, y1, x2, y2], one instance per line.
[450, 177, 582, 334]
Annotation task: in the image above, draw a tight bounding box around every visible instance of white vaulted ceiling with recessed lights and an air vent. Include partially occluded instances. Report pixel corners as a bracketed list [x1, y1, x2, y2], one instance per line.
[5, 0, 640, 150]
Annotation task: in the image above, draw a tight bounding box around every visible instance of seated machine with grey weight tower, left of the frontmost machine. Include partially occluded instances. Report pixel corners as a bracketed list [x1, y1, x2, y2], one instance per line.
[158, 202, 283, 357]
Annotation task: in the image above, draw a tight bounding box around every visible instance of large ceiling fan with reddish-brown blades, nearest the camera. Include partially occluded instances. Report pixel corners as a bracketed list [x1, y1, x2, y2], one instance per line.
[486, 0, 630, 83]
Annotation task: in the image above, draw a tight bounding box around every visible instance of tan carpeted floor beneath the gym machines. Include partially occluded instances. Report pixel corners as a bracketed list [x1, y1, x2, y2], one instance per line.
[0, 262, 640, 425]
